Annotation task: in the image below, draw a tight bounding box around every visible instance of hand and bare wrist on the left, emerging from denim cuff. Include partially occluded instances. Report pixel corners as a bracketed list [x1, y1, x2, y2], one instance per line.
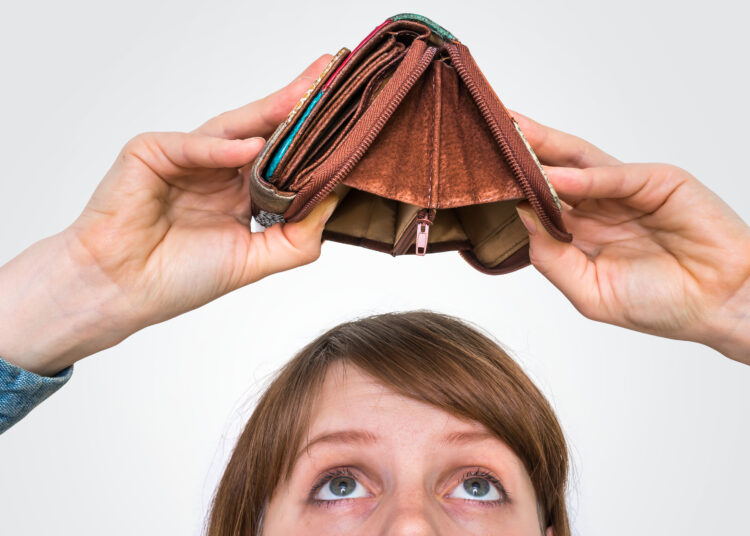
[0, 55, 336, 374]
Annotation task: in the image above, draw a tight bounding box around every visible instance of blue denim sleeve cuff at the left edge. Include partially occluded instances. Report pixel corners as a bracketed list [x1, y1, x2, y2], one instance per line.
[0, 357, 73, 434]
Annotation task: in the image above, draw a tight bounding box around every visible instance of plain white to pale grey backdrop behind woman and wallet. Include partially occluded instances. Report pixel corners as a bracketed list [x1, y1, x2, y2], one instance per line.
[0, 0, 750, 536]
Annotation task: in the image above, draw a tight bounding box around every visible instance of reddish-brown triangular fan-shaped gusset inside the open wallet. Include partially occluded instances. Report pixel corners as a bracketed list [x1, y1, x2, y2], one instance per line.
[340, 61, 524, 209]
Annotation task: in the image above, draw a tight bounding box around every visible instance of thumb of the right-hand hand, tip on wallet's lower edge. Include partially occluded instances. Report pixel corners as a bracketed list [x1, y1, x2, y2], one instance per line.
[516, 201, 600, 318]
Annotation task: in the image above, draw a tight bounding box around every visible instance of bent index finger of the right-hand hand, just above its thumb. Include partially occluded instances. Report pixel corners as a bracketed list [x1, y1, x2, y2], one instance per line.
[544, 164, 687, 212]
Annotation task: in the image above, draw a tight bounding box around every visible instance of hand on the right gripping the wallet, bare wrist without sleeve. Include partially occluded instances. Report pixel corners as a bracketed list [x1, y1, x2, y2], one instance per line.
[512, 112, 750, 364]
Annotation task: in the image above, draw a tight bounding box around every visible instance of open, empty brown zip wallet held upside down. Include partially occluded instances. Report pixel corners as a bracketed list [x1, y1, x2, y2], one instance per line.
[249, 13, 573, 274]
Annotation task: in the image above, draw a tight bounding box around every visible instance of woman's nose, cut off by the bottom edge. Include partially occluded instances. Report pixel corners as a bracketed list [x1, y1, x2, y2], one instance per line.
[381, 482, 443, 536]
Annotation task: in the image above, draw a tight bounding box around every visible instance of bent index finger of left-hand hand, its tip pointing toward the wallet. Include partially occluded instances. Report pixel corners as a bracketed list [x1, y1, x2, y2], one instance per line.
[128, 132, 265, 178]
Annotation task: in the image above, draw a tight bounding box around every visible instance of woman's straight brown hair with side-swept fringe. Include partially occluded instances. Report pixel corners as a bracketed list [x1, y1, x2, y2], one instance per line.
[208, 311, 570, 536]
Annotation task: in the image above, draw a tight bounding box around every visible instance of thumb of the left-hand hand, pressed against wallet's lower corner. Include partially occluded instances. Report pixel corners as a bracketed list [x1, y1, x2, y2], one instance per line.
[244, 192, 340, 284]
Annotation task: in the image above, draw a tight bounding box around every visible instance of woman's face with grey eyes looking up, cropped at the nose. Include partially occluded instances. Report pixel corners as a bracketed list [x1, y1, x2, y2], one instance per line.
[263, 364, 552, 536]
